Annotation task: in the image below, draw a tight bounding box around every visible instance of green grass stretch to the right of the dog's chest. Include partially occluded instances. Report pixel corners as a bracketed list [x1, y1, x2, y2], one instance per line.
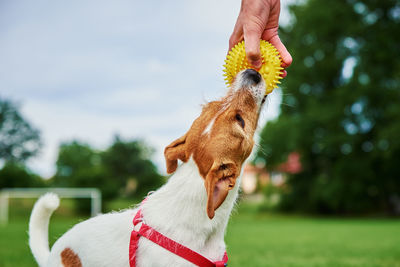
[225, 208, 400, 266]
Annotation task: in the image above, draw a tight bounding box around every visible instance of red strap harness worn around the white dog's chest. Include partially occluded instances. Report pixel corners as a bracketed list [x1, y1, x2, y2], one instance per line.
[129, 204, 228, 267]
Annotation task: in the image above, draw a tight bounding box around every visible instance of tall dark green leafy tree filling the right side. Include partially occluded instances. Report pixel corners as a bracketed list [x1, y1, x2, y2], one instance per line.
[257, 0, 400, 213]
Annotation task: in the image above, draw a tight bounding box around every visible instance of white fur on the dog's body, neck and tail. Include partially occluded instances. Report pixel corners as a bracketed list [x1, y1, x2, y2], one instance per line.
[29, 159, 240, 267]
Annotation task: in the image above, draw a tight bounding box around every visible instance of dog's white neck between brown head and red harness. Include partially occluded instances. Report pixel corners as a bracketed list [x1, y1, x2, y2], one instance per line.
[142, 159, 240, 258]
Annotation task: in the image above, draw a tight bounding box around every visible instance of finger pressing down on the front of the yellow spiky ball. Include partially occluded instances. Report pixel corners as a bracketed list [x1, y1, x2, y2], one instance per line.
[244, 27, 262, 69]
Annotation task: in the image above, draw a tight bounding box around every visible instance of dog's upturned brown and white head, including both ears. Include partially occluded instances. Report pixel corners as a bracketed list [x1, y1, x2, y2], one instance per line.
[164, 69, 265, 219]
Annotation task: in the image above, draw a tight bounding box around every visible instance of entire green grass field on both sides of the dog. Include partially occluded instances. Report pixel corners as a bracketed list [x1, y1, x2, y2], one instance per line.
[0, 202, 400, 267]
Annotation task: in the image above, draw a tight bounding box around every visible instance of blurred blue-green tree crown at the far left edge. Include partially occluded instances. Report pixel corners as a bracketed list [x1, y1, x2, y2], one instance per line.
[0, 98, 41, 162]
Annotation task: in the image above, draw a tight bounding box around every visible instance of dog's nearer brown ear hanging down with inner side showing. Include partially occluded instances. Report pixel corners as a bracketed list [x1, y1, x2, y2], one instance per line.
[204, 162, 239, 219]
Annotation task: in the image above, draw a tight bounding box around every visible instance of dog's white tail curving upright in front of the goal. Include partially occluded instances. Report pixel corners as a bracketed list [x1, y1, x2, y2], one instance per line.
[29, 193, 60, 267]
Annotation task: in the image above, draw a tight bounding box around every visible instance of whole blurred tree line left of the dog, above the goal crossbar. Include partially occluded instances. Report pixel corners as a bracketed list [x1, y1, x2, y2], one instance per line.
[0, 98, 164, 213]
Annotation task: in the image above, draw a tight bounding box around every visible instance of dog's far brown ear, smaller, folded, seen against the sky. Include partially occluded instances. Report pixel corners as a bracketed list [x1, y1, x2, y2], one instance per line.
[164, 134, 188, 173]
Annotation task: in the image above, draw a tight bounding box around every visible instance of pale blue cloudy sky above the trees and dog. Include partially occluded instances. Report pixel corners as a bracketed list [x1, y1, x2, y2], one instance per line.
[0, 0, 290, 177]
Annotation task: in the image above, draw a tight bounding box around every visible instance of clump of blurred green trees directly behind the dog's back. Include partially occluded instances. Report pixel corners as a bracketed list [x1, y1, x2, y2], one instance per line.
[53, 137, 162, 211]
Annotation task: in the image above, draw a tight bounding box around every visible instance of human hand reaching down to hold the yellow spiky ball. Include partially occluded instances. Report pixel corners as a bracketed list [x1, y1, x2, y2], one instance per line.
[229, 0, 292, 77]
